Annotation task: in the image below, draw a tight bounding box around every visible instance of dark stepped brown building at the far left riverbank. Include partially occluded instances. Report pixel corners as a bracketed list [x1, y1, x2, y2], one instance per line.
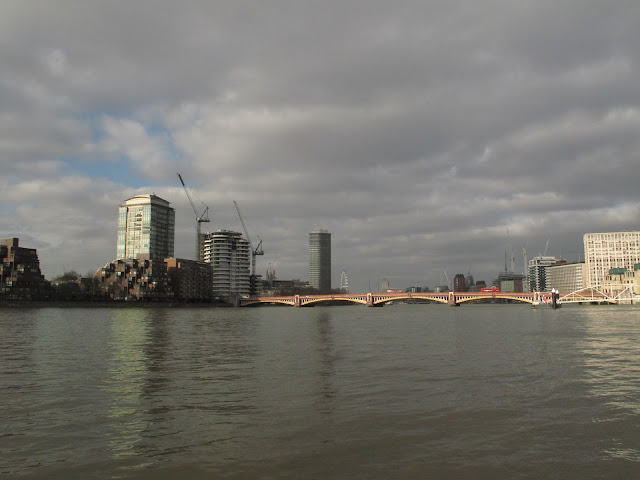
[0, 237, 50, 300]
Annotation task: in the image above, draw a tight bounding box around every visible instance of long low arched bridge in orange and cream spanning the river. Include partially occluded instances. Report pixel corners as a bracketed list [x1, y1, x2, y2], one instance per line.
[240, 292, 551, 307]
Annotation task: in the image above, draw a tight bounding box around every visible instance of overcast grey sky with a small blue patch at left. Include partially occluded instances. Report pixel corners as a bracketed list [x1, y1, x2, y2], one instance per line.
[0, 0, 640, 291]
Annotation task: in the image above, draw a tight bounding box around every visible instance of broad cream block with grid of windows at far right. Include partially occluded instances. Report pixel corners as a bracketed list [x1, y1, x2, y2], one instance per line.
[584, 231, 640, 287]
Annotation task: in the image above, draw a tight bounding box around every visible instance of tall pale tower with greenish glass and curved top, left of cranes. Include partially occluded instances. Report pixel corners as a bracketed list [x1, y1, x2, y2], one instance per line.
[116, 194, 175, 260]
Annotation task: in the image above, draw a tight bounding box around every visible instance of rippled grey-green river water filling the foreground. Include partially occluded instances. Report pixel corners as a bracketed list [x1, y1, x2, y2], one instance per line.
[0, 305, 640, 479]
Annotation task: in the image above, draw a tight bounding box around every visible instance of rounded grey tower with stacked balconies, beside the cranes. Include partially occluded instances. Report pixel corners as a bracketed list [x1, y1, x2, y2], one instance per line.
[203, 230, 251, 301]
